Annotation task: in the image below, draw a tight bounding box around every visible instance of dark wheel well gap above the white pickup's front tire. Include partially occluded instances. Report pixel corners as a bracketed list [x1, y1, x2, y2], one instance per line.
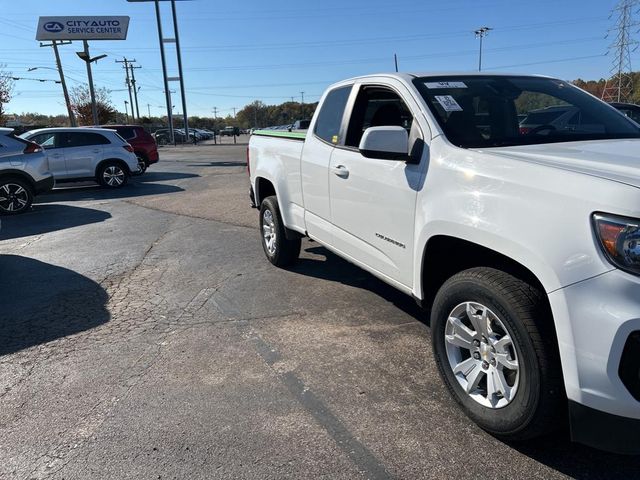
[422, 235, 551, 311]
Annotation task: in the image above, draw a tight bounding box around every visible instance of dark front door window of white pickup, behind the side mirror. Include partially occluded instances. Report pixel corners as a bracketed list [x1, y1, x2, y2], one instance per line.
[345, 86, 413, 148]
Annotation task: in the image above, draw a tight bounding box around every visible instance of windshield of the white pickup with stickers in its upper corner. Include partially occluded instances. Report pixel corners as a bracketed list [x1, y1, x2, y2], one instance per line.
[414, 76, 640, 148]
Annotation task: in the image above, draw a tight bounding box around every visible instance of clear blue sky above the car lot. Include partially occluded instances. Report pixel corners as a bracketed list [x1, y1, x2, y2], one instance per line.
[0, 0, 640, 116]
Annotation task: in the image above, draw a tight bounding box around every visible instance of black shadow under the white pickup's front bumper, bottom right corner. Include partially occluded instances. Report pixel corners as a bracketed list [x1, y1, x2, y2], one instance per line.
[511, 434, 640, 480]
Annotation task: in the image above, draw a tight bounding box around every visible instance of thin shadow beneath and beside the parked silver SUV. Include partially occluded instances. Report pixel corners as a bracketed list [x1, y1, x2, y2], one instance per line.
[34, 181, 184, 203]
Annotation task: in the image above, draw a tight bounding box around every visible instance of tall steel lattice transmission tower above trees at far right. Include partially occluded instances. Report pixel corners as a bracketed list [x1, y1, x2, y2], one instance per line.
[602, 0, 640, 102]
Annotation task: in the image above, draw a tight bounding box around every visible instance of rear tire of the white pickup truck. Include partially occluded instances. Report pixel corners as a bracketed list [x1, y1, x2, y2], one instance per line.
[260, 195, 301, 267]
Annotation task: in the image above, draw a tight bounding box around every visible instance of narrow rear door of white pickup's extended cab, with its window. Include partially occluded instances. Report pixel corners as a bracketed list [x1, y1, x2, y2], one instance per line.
[300, 85, 353, 245]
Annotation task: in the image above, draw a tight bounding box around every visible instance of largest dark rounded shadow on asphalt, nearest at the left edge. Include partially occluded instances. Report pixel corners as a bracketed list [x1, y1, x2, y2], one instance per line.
[0, 255, 109, 355]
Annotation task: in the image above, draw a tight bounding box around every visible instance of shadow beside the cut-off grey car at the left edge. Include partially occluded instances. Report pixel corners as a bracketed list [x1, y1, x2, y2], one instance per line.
[0, 205, 111, 240]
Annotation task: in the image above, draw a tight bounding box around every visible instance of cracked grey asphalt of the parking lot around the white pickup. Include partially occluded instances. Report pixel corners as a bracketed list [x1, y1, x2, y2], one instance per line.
[0, 145, 640, 479]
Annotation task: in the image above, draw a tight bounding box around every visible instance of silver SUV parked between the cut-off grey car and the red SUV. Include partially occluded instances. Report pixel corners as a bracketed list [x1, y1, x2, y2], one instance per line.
[21, 128, 139, 188]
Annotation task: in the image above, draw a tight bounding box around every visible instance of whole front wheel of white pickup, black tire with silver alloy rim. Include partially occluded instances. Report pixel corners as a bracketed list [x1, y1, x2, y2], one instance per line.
[431, 267, 565, 441]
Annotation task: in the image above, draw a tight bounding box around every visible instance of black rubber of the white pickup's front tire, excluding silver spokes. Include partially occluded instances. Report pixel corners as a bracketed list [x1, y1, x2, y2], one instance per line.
[431, 267, 566, 441]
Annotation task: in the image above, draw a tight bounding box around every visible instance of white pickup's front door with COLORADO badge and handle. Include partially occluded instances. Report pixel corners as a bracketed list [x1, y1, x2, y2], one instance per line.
[329, 85, 425, 287]
